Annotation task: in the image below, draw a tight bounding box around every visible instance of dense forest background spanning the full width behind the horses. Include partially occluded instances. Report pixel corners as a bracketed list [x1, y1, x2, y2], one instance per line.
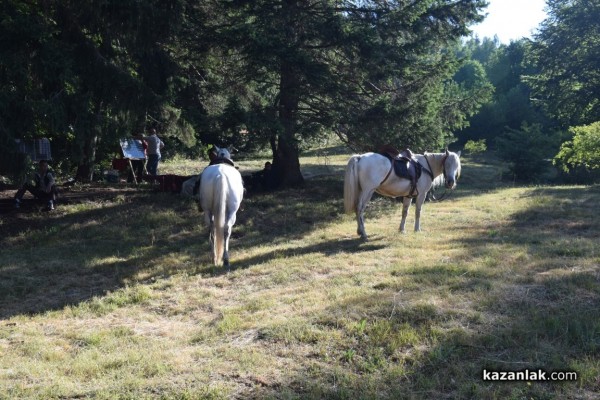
[0, 0, 600, 185]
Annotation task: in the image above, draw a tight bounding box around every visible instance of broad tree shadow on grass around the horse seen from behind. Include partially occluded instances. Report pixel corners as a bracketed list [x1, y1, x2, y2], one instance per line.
[0, 178, 352, 319]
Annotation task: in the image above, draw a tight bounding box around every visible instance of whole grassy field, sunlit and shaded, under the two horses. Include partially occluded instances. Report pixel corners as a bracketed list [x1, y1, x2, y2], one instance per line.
[0, 150, 600, 399]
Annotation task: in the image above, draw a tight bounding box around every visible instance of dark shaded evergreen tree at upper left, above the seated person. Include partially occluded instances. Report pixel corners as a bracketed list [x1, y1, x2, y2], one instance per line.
[0, 0, 191, 179]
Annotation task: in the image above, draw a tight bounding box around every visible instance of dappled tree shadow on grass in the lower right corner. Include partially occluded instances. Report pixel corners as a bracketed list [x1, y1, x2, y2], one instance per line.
[255, 271, 600, 399]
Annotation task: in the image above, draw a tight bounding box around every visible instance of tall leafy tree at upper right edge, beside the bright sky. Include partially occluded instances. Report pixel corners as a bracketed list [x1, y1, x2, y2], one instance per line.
[528, 0, 600, 128]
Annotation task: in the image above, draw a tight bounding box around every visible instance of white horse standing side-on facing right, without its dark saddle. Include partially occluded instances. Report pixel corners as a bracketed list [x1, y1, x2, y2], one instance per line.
[344, 150, 460, 240]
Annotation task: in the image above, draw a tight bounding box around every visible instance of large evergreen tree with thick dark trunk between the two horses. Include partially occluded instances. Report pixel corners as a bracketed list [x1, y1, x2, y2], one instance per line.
[200, 0, 485, 185]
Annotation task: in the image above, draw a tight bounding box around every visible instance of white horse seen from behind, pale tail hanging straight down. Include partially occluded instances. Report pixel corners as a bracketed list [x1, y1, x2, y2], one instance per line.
[200, 149, 244, 267]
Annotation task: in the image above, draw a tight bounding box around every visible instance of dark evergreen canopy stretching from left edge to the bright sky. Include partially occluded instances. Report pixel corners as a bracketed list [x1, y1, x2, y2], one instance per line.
[0, 0, 485, 184]
